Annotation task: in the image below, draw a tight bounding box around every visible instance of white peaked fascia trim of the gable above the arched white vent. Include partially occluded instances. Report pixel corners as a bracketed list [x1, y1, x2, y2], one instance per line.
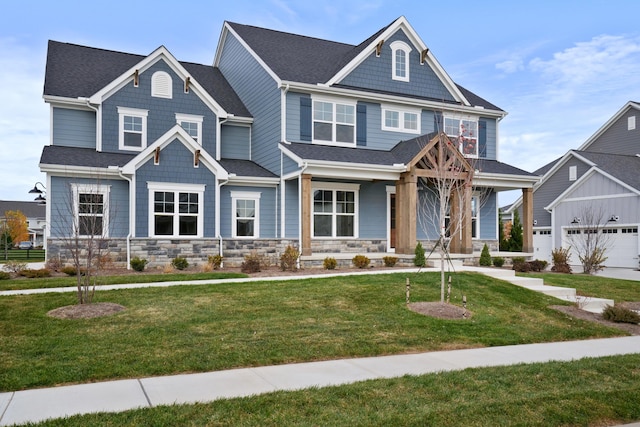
[89, 46, 228, 118]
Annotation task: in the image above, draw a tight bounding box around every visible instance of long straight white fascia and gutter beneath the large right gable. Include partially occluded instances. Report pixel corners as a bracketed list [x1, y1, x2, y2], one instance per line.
[282, 81, 507, 119]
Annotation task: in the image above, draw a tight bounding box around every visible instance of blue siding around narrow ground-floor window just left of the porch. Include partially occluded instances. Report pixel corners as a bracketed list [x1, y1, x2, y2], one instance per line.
[220, 185, 279, 239]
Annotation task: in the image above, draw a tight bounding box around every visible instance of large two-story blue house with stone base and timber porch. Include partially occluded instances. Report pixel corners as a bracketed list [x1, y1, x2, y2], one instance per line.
[40, 17, 538, 264]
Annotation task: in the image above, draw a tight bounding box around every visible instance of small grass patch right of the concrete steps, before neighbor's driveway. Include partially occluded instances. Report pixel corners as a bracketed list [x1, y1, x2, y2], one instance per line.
[523, 273, 640, 303]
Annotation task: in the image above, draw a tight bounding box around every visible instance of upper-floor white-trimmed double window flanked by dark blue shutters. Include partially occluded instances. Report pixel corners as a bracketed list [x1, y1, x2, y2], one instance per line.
[313, 99, 356, 145]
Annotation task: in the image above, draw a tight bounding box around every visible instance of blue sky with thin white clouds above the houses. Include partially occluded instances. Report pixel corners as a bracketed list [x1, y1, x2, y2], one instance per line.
[0, 0, 640, 204]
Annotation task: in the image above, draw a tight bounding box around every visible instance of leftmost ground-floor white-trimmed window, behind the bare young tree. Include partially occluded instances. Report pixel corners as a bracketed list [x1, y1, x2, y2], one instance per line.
[71, 184, 111, 237]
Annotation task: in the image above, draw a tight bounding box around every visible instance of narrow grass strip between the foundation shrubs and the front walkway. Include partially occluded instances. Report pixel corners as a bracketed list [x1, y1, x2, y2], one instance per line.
[0, 272, 248, 291]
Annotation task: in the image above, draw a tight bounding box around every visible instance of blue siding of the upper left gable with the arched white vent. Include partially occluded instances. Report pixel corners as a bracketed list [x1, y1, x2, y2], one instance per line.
[102, 61, 217, 157]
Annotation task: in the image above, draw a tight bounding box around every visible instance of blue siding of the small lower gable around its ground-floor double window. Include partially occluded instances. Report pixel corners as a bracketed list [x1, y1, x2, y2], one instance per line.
[136, 140, 217, 237]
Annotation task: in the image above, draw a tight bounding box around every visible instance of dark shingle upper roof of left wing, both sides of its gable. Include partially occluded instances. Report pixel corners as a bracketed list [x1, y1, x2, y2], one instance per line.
[44, 40, 251, 117]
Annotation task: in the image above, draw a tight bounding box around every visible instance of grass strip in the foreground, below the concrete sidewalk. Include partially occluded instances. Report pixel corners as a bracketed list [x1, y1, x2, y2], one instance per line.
[31, 355, 640, 427]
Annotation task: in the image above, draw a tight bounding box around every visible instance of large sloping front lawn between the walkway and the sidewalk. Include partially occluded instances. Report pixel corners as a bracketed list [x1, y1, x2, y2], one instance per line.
[0, 273, 623, 391]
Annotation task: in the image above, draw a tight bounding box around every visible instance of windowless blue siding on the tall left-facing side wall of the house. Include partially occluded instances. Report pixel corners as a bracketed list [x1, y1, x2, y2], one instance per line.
[219, 33, 282, 174]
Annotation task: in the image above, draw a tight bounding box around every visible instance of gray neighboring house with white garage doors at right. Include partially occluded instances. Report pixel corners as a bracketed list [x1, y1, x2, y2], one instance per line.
[509, 102, 640, 268]
